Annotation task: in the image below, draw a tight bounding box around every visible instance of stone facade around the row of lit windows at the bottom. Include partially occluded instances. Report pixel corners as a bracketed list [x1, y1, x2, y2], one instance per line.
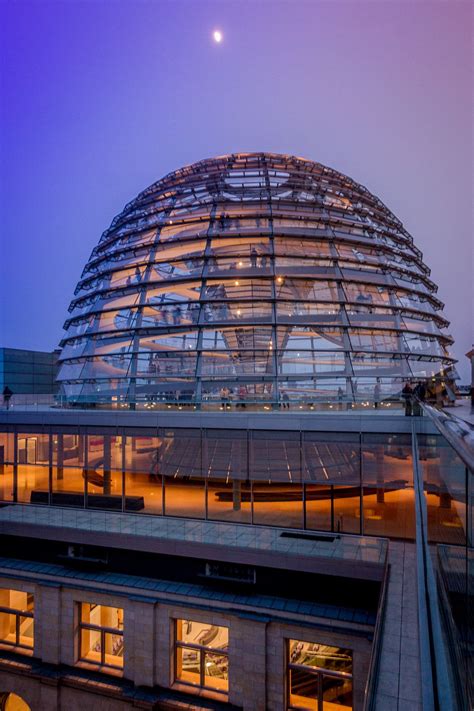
[0, 577, 371, 711]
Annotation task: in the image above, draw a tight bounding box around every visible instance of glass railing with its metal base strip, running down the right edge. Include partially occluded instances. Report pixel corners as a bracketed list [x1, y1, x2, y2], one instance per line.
[413, 403, 474, 711]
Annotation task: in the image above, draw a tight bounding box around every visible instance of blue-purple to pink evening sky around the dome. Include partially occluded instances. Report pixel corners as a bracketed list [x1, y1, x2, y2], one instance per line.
[0, 0, 473, 381]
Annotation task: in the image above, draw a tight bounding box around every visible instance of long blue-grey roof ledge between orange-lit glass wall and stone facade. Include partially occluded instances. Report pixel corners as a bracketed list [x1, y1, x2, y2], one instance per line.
[0, 504, 388, 581]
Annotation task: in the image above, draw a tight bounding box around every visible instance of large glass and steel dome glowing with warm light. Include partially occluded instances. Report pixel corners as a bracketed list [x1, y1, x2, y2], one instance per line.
[59, 153, 454, 408]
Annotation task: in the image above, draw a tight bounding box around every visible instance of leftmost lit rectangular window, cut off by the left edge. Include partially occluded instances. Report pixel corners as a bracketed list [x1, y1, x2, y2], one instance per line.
[0, 589, 34, 649]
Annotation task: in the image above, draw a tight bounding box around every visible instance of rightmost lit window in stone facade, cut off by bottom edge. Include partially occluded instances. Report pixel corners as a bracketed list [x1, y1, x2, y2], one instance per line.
[288, 639, 352, 711]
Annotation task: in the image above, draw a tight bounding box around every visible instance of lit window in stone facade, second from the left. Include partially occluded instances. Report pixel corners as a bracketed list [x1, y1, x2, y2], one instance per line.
[79, 602, 123, 669]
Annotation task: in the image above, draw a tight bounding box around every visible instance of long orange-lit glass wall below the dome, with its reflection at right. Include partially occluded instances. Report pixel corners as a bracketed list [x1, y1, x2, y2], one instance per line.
[0, 428, 422, 542]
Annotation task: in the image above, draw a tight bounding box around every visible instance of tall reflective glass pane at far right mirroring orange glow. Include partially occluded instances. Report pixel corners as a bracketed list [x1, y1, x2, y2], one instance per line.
[417, 406, 474, 711]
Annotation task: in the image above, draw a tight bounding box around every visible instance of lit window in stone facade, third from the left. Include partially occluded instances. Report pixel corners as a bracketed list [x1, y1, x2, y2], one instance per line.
[176, 620, 229, 692]
